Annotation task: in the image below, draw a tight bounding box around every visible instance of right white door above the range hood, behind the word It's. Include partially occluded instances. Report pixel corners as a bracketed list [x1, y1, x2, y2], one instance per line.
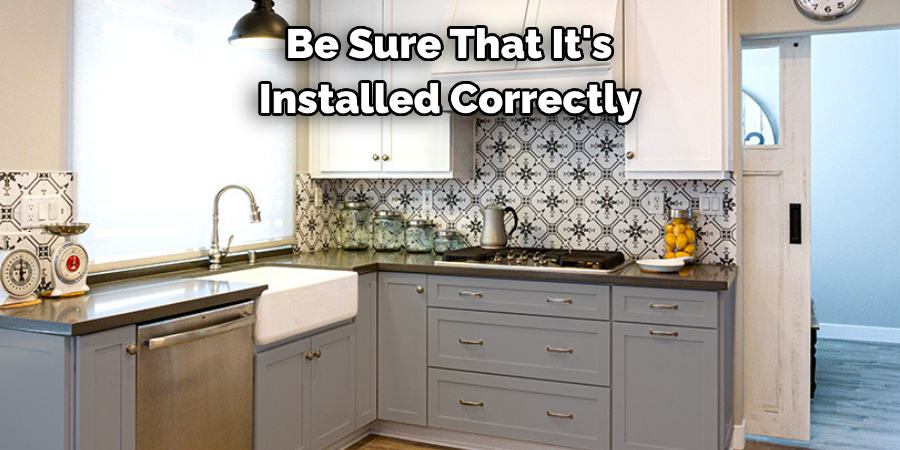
[517, 0, 621, 70]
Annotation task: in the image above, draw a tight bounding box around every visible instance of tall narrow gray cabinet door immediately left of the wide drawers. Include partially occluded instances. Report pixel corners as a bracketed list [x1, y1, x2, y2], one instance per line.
[378, 273, 428, 425]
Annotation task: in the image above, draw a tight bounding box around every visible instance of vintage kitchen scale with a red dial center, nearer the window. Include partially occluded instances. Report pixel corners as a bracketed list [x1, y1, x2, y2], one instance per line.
[41, 222, 91, 298]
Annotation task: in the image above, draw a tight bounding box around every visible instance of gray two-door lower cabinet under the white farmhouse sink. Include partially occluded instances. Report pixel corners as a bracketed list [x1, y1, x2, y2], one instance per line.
[253, 324, 356, 450]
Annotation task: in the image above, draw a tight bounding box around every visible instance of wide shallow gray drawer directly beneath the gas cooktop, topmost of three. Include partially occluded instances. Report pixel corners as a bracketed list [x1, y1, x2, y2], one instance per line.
[428, 275, 610, 320]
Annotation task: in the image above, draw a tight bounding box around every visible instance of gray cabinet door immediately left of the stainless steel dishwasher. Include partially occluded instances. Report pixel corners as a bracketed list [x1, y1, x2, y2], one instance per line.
[75, 325, 137, 450]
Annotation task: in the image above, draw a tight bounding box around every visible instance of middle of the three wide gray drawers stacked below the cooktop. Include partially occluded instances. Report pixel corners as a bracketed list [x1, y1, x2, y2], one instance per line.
[428, 308, 610, 386]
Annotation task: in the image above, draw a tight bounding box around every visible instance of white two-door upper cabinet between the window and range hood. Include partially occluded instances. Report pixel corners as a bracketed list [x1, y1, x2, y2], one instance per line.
[310, 0, 475, 178]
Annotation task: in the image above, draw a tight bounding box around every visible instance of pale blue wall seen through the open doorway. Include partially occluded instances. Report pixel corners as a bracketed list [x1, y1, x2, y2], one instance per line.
[811, 30, 900, 328]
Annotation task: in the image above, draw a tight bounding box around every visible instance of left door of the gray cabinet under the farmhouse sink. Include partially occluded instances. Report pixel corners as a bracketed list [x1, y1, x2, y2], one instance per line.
[253, 339, 311, 450]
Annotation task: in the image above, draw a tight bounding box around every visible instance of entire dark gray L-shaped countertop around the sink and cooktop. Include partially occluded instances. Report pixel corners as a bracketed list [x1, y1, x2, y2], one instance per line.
[0, 250, 737, 336]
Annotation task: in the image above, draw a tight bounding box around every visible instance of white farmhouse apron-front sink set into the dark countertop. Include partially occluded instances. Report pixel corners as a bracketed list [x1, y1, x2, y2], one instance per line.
[198, 267, 358, 345]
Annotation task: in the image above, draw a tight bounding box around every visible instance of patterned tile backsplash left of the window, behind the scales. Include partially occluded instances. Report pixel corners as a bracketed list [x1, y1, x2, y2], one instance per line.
[0, 172, 75, 292]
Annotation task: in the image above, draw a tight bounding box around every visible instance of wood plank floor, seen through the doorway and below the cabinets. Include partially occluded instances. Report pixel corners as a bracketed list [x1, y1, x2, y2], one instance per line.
[349, 340, 900, 450]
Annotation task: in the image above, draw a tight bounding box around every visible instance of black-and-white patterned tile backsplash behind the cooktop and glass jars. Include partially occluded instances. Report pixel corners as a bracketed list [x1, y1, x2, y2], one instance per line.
[295, 116, 736, 264]
